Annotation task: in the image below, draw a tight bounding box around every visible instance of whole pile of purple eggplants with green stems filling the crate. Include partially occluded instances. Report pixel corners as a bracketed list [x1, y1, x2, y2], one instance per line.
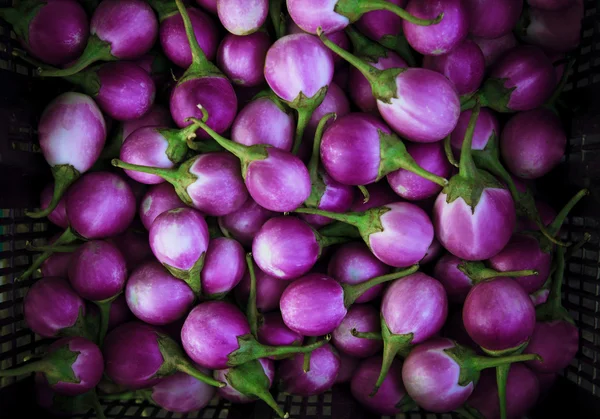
[0, 0, 589, 419]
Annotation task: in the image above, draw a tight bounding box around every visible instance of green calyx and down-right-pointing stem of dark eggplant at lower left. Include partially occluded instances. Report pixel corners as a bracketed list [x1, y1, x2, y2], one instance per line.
[156, 332, 225, 387]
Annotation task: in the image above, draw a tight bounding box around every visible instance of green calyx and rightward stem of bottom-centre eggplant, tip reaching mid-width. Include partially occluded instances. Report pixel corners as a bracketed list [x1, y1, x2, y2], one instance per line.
[227, 334, 331, 367]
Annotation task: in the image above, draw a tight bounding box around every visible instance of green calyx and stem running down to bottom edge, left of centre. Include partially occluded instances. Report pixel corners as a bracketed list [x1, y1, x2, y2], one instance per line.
[225, 360, 290, 419]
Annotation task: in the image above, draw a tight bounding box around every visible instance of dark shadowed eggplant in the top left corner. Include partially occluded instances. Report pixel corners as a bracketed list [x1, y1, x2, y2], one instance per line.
[0, 0, 89, 66]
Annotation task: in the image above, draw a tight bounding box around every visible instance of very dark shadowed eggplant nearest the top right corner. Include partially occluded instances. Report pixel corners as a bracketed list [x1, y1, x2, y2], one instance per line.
[523, 0, 584, 52]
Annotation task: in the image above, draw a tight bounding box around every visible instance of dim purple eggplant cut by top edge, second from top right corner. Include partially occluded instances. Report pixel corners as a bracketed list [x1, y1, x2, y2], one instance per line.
[465, 0, 523, 39]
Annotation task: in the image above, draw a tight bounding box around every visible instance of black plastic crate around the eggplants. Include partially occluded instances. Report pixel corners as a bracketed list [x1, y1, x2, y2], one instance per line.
[0, 0, 600, 419]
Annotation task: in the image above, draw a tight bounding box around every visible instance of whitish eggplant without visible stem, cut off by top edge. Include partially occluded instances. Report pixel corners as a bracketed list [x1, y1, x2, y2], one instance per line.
[217, 0, 269, 36]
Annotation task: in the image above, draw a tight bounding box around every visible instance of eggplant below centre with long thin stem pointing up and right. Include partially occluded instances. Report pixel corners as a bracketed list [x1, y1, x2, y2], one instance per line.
[279, 265, 418, 336]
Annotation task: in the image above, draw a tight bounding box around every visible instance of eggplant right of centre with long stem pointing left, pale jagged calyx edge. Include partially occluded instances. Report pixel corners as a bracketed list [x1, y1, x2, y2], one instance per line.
[296, 202, 433, 268]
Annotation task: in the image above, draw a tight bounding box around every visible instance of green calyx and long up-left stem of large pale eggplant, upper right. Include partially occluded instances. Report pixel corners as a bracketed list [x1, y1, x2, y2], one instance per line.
[317, 27, 406, 103]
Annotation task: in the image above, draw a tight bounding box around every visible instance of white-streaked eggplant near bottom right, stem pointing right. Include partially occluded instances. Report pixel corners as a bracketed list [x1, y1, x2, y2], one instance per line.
[402, 338, 539, 417]
